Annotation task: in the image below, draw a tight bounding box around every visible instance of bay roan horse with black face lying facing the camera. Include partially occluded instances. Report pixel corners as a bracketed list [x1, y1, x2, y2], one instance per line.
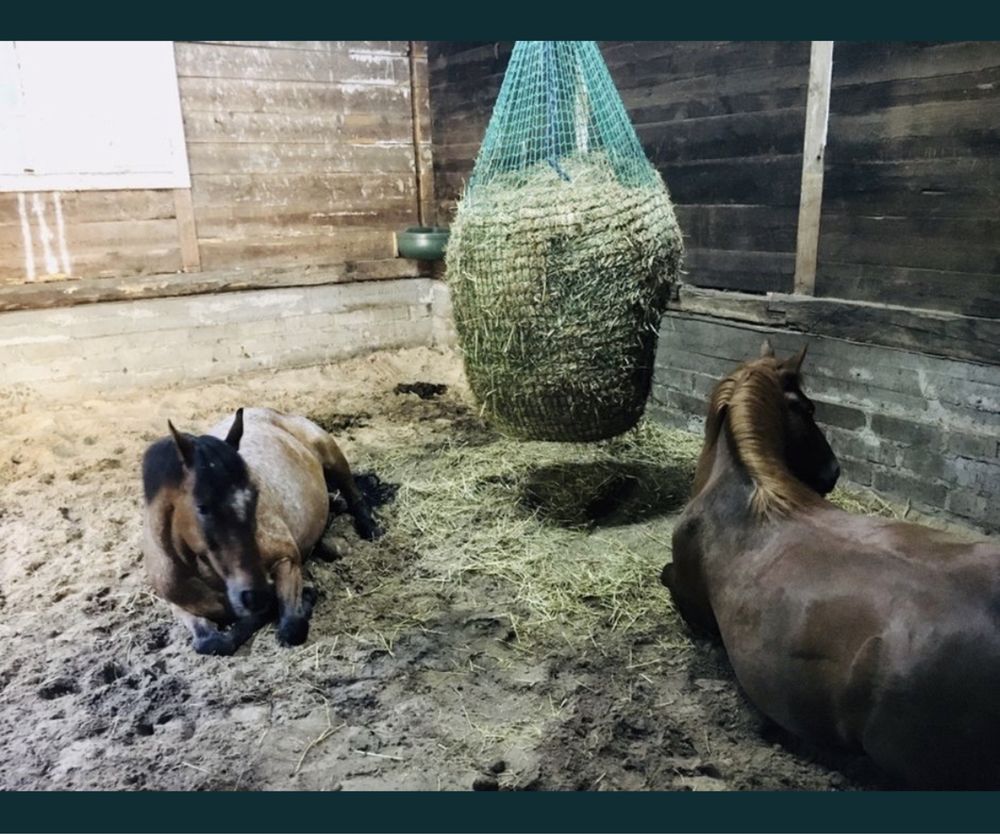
[143, 408, 381, 654]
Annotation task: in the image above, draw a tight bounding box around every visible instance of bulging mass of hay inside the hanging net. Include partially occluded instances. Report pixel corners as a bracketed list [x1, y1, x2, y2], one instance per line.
[446, 152, 682, 441]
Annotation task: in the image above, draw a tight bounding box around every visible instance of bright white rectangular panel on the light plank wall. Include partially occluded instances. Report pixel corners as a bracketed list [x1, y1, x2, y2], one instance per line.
[0, 41, 191, 191]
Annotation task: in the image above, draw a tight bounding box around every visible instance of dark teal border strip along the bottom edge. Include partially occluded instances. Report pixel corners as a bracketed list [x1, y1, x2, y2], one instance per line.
[0, 792, 1000, 834]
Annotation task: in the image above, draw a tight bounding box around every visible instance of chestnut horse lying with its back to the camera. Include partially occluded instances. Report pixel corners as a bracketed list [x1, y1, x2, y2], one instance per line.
[662, 343, 1000, 789]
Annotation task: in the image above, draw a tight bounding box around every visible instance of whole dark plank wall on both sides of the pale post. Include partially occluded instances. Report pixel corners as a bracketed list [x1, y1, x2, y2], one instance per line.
[431, 41, 1000, 318]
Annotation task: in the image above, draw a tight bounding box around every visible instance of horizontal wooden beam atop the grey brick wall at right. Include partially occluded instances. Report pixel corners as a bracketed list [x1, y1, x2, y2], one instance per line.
[669, 285, 1000, 365]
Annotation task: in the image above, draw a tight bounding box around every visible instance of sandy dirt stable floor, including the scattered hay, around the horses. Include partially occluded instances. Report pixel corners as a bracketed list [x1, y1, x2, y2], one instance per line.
[0, 349, 892, 790]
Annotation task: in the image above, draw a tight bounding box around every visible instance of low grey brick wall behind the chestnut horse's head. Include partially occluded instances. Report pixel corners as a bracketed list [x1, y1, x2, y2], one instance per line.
[651, 315, 1000, 533]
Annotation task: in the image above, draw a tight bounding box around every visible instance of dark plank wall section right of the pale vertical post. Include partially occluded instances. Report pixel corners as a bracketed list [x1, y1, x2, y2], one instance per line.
[816, 42, 1000, 318]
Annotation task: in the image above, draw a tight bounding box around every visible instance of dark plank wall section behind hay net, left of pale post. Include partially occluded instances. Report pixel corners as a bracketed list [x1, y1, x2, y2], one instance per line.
[430, 41, 809, 292]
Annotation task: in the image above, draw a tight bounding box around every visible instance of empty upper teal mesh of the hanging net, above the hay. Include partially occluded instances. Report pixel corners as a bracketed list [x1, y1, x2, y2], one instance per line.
[467, 41, 657, 193]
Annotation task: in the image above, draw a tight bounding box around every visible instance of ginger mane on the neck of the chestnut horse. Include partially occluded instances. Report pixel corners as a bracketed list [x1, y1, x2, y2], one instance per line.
[694, 359, 822, 518]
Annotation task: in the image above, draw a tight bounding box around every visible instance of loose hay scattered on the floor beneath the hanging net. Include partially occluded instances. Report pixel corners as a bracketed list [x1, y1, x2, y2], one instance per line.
[376, 421, 908, 644]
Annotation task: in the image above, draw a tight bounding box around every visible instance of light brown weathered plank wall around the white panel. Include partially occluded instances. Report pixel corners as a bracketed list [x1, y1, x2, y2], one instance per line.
[0, 41, 429, 300]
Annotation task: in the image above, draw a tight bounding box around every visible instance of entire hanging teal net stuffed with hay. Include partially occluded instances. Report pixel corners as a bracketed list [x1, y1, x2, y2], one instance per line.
[446, 41, 682, 441]
